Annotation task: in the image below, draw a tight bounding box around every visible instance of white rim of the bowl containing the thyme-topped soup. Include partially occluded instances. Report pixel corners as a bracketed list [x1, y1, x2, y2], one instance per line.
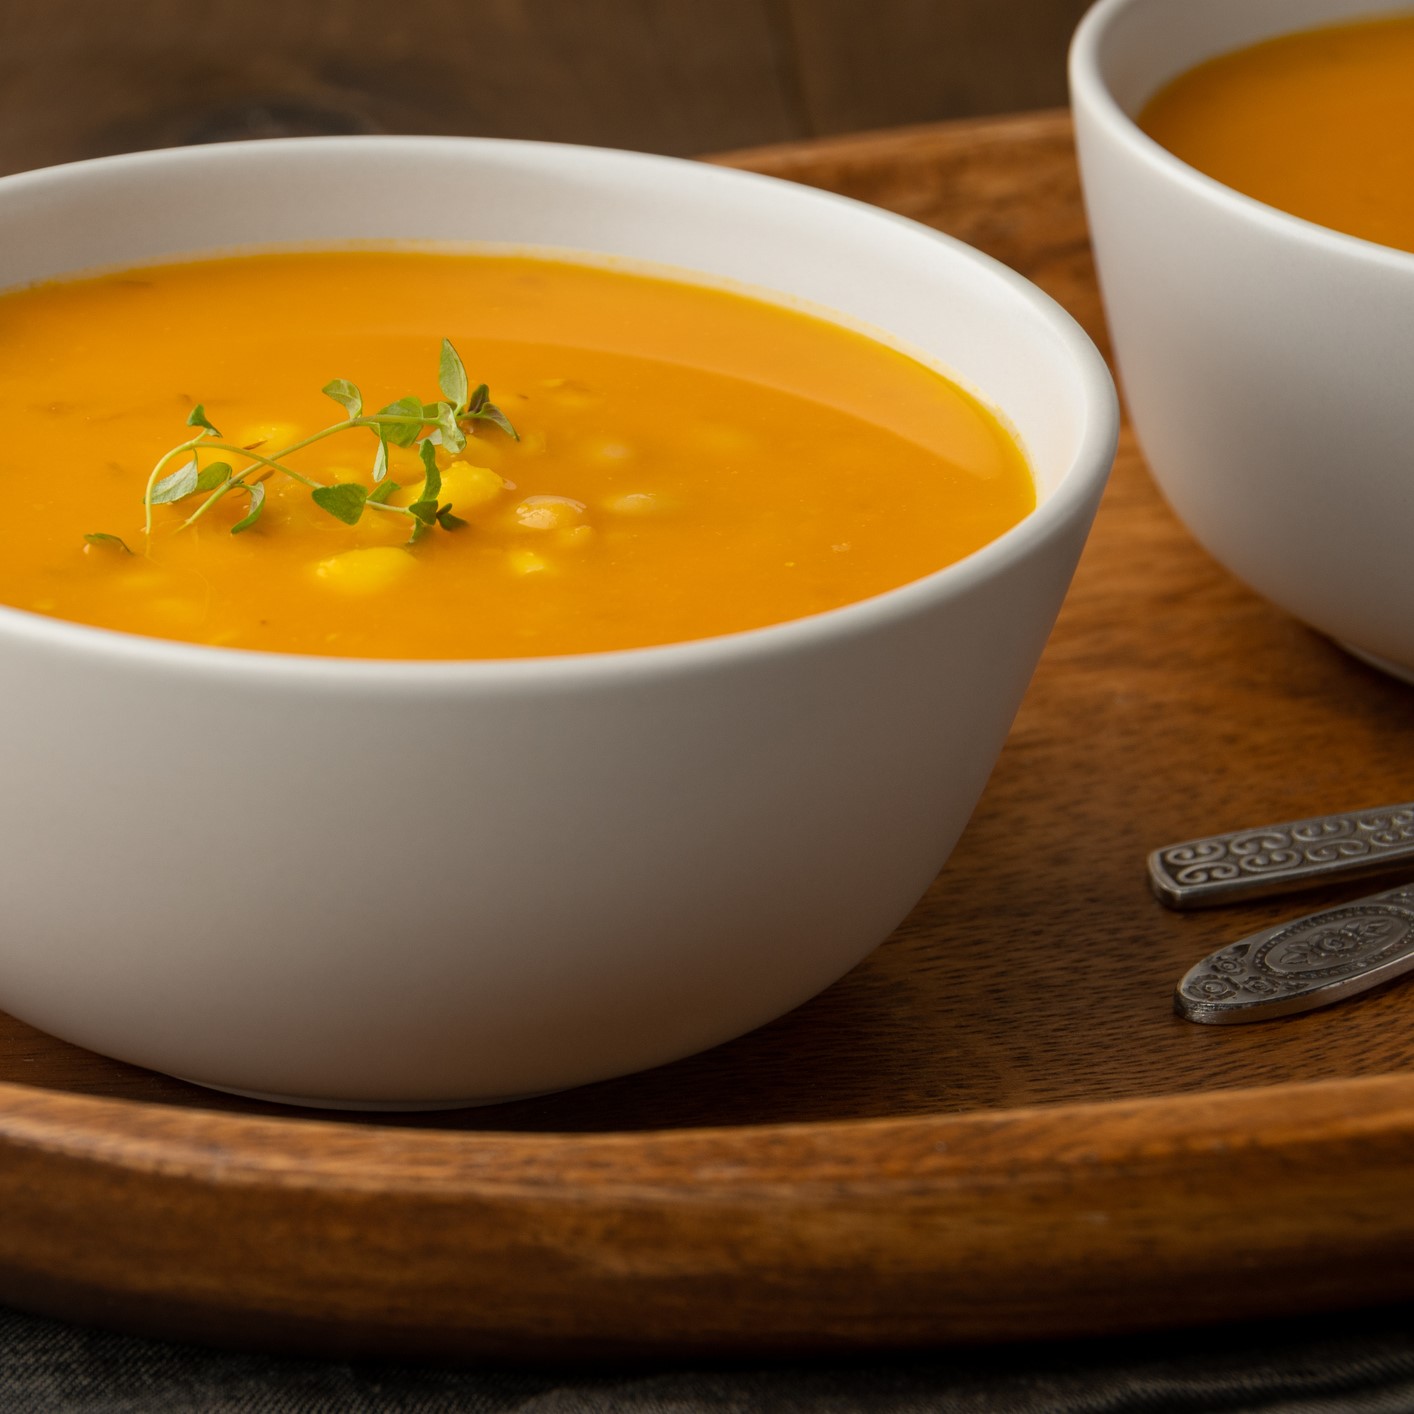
[0, 134, 1120, 691]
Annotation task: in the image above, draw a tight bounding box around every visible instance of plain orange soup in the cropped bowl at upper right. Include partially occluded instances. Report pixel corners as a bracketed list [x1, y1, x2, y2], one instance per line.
[1138, 11, 1414, 250]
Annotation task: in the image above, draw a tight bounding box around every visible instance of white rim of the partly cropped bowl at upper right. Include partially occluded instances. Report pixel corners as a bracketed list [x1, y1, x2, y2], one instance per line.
[1066, 0, 1414, 276]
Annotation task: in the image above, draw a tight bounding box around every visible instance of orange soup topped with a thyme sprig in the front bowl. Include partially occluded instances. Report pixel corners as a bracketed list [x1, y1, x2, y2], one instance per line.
[0, 249, 1035, 659]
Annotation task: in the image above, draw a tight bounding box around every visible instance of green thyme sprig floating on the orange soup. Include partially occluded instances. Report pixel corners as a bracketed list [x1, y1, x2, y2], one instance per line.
[85, 339, 520, 553]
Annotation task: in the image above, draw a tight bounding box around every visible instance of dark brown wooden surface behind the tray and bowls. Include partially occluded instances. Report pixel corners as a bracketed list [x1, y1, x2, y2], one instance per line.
[0, 0, 1087, 171]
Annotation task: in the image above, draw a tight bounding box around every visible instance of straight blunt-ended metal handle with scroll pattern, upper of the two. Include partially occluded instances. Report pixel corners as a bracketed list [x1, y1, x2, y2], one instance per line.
[1148, 803, 1414, 908]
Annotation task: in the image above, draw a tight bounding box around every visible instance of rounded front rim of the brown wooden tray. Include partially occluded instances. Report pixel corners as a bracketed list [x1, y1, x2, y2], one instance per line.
[11, 1075, 1414, 1362]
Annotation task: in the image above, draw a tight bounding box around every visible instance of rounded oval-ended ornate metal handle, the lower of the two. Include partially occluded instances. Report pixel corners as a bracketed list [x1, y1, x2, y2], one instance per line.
[1174, 888, 1414, 1025]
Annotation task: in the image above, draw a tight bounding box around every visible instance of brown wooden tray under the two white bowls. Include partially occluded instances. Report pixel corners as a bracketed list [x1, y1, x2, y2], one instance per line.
[0, 115, 1414, 1359]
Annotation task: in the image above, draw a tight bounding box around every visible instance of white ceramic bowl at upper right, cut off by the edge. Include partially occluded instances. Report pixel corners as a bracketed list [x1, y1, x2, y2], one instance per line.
[1070, 0, 1414, 680]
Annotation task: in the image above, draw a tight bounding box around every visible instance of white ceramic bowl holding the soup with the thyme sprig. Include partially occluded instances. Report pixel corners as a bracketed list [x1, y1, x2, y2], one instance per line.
[0, 139, 1116, 1107]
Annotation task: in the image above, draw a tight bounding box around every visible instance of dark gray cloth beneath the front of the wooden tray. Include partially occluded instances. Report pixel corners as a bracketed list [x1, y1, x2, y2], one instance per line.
[0, 1307, 1414, 1414]
